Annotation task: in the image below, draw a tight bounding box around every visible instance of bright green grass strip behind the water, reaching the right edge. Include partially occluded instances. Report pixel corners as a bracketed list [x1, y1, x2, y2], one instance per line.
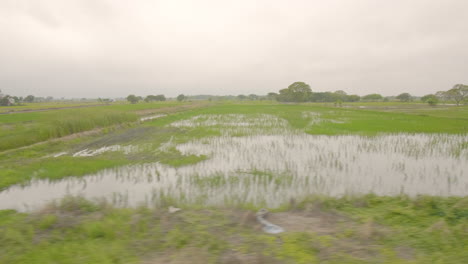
[147, 103, 468, 135]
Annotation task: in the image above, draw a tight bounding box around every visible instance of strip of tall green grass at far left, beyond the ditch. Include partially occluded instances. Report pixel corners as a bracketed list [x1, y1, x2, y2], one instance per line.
[0, 102, 206, 152]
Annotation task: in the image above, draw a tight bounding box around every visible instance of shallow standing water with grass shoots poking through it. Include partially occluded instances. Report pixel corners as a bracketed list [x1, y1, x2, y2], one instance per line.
[0, 114, 468, 211]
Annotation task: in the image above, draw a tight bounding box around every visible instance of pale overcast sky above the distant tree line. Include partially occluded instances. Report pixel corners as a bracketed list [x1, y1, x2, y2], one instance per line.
[0, 0, 468, 97]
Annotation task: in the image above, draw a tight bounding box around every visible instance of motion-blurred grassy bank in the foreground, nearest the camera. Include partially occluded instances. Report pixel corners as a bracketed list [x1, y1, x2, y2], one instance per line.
[0, 195, 468, 264]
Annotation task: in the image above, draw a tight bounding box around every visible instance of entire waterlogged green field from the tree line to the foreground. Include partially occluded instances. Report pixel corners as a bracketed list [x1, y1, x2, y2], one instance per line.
[0, 101, 468, 263]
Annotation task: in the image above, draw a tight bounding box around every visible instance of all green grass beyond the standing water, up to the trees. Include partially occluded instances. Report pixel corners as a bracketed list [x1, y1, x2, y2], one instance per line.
[0, 102, 468, 188]
